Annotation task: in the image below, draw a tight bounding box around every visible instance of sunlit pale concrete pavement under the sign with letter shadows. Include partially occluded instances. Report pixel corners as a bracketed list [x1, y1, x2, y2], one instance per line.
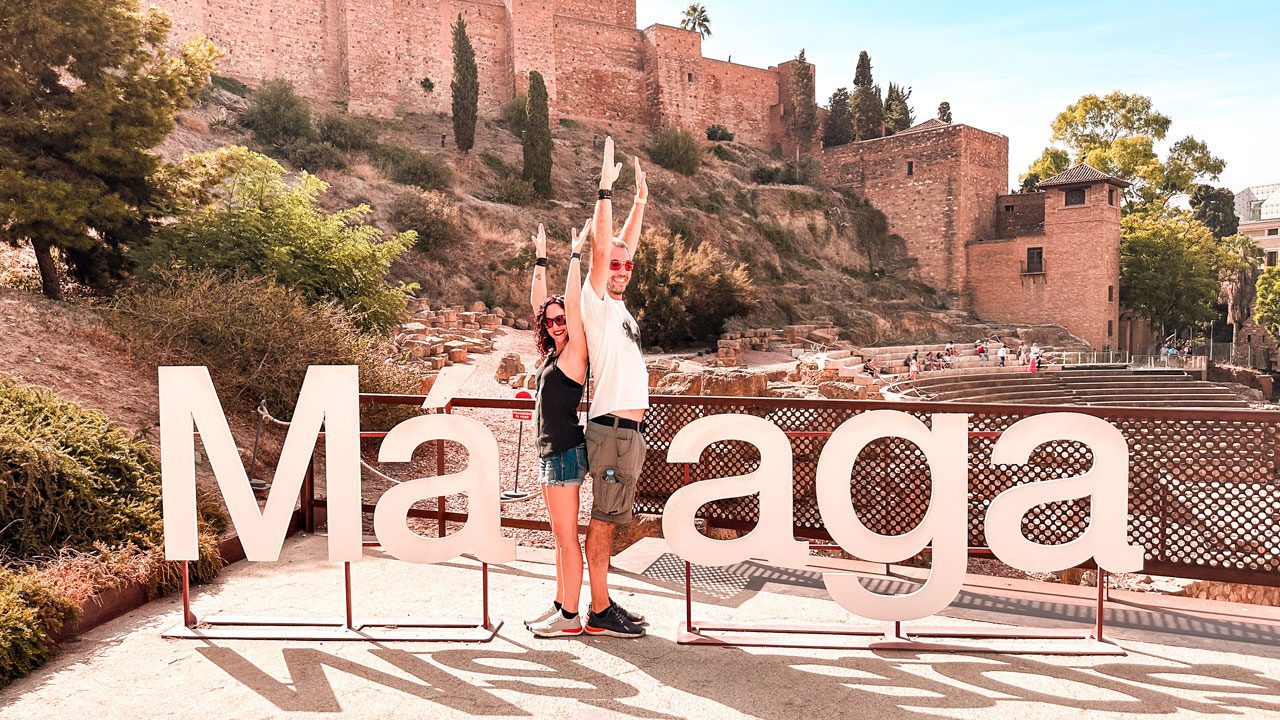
[0, 537, 1280, 720]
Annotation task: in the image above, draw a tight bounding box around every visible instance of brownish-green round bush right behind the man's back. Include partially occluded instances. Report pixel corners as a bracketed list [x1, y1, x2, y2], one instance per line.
[626, 232, 755, 347]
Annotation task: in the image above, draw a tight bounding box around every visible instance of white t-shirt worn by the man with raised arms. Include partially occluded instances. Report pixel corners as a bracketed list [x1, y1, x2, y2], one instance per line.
[581, 279, 649, 418]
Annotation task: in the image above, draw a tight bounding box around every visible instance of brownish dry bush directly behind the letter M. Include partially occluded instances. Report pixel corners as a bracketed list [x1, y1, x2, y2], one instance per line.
[110, 269, 417, 418]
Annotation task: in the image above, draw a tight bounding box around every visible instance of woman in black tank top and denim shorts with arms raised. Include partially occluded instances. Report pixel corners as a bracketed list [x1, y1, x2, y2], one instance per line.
[525, 222, 591, 637]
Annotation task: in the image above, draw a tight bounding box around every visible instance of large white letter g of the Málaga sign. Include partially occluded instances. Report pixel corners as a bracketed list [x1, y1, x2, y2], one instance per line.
[817, 410, 969, 620]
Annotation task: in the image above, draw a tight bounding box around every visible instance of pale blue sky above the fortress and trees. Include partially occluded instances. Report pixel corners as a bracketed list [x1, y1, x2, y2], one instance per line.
[637, 0, 1280, 191]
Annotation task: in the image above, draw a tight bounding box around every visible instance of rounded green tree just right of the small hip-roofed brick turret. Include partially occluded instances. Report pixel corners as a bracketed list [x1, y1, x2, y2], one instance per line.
[1120, 211, 1230, 332]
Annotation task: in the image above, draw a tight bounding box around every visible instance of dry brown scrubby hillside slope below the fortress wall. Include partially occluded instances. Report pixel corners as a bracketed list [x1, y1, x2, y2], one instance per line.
[159, 78, 945, 342]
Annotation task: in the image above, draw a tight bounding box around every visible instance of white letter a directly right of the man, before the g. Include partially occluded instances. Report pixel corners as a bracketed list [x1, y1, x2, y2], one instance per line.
[662, 414, 809, 568]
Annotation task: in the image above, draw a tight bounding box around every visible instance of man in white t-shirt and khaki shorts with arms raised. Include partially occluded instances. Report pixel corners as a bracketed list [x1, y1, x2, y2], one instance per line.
[581, 137, 649, 638]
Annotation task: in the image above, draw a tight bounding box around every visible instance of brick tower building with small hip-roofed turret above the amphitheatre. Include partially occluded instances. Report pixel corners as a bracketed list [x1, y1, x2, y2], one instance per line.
[819, 119, 1132, 348]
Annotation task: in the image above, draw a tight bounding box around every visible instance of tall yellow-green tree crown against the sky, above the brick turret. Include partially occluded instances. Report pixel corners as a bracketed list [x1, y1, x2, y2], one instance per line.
[1028, 92, 1226, 210]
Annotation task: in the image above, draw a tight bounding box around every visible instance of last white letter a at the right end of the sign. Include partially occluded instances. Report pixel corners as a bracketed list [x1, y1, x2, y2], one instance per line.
[986, 413, 1143, 573]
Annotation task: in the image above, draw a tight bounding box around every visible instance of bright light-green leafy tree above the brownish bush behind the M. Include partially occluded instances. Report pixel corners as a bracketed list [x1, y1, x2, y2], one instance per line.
[134, 147, 417, 328]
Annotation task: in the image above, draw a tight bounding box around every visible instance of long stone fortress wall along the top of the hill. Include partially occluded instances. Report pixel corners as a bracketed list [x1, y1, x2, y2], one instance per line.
[155, 0, 791, 150]
